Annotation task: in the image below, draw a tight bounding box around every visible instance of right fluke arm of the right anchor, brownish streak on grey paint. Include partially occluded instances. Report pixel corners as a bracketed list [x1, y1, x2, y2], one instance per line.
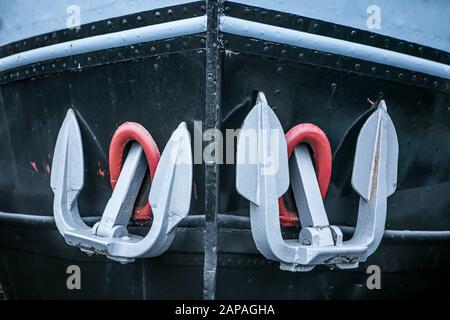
[345, 100, 398, 257]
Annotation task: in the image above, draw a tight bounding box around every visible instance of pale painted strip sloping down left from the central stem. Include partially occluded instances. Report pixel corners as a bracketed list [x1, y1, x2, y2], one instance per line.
[0, 16, 206, 72]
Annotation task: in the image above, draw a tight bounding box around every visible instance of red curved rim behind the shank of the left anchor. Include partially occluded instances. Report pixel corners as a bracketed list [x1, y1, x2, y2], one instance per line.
[109, 122, 160, 221]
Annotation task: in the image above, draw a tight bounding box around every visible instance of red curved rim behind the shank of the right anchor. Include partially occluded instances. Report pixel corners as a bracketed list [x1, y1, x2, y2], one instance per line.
[278, 123, 332, 227]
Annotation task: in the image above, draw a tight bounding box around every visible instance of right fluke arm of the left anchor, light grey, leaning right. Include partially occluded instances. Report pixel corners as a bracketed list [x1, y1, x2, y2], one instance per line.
[111, 123, 192, 257]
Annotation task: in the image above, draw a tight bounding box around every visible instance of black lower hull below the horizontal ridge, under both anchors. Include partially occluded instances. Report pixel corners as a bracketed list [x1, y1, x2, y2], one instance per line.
[0, 216, 450, 299]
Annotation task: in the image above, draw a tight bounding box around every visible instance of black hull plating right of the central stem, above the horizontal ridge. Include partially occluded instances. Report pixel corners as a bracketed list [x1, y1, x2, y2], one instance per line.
[220, 52, 450, 230]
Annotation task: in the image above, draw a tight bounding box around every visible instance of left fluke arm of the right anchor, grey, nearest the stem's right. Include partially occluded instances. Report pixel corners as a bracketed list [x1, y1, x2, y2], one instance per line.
[236, 92, 302, 260]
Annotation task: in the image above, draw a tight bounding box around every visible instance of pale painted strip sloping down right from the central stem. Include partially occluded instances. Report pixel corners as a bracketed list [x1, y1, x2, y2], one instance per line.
[220, 16, 450, 79]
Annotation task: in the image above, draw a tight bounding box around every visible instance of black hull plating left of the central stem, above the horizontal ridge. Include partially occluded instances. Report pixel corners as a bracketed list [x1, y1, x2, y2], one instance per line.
[0, 45, 206, 216]
